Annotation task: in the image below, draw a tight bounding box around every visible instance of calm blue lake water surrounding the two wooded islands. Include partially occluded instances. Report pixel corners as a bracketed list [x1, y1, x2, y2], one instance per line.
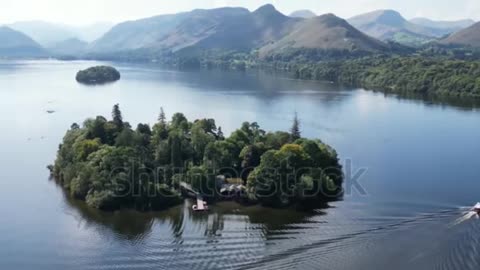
[0, 61, 480, 270]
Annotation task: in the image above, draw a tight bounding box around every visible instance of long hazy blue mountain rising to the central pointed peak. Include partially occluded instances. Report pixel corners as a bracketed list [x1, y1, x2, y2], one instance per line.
[88, 5, 299, 55]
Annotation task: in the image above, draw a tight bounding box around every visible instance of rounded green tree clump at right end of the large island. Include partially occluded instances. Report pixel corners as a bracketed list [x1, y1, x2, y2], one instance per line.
[248, 139, 343, 206]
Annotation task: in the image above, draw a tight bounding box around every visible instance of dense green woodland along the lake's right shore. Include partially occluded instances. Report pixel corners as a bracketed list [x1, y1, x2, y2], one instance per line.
[288, 56, 480, 97]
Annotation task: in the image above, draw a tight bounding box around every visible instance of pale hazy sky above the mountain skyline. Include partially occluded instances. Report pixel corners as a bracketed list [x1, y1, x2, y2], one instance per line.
[0, 0, 480, 24]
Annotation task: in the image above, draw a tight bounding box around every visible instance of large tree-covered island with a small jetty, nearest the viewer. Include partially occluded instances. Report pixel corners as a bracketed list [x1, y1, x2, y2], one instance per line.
[49, 104, 343, 211]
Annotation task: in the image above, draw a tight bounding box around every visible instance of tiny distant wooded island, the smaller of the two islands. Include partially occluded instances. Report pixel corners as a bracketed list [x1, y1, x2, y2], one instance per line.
[75, 66, 120, 84]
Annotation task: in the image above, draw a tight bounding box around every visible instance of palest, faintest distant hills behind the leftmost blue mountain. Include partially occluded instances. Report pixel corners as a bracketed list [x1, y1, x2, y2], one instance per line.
[8, 21, 113, 47]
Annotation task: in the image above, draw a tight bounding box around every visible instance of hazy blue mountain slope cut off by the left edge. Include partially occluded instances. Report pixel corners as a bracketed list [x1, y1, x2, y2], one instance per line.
[0, 26, 46, 57]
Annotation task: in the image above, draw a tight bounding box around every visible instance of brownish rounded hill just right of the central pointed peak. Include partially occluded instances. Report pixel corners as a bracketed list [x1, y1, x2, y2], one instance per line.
[260, 14, 388, 56]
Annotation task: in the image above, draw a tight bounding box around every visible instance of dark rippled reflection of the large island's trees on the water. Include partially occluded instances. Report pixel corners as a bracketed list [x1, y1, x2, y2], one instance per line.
[64, 188, 325, 241]
